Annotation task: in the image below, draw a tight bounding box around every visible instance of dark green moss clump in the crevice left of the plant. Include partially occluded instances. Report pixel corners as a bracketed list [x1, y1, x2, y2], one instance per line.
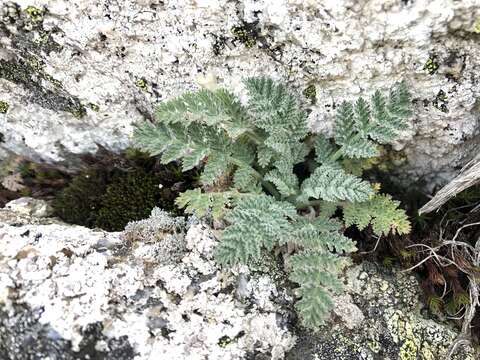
[51, 148, 196, 231]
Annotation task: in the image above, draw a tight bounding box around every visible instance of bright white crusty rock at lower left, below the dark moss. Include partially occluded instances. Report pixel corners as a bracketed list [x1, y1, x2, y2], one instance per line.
[0, 209, 295, 360]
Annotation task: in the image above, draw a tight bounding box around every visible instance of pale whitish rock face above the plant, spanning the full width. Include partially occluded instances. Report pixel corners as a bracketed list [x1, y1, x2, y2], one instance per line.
[0, 0, 480, 188]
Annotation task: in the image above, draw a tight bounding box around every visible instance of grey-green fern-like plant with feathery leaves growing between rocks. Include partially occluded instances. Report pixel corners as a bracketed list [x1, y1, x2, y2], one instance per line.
[134, 77, 411, 327]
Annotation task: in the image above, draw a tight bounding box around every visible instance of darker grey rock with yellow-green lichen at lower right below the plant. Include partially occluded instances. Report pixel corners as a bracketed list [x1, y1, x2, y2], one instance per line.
[286, 262, 478, 360]
